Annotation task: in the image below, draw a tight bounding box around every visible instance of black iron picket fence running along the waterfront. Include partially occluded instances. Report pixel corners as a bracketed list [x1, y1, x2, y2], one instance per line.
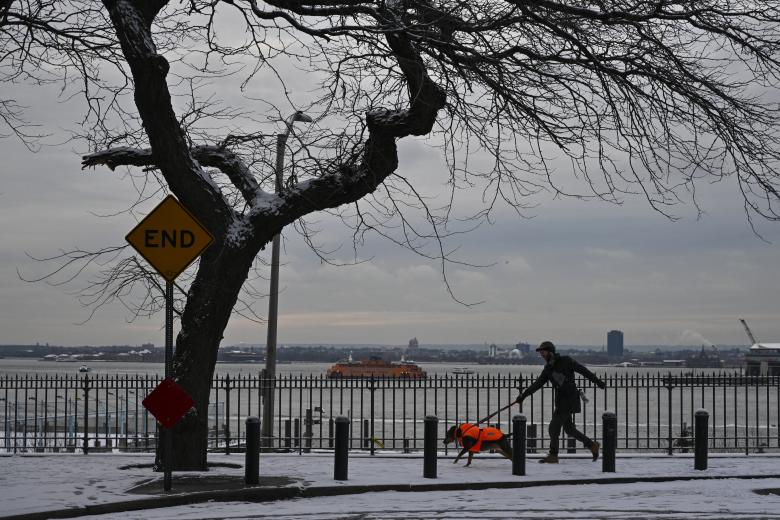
[0, 372, 780, 453]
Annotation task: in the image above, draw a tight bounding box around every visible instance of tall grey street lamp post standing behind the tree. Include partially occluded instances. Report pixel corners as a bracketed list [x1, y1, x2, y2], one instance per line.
[260, 110, 312, 447]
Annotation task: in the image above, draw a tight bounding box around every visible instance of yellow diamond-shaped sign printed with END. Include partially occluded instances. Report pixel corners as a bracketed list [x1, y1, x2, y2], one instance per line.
[125, 195, 214, 282]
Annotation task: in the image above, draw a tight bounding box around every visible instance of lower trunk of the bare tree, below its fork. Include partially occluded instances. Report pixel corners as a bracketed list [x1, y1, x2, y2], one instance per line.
[173, 244, 256, 471]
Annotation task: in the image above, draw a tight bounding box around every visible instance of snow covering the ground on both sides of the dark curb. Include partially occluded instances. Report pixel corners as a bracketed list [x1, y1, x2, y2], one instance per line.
[0, 453, 780, 520]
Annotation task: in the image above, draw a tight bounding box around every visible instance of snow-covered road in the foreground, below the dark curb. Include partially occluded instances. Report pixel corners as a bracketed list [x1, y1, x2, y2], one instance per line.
[87, 480, 780, 520]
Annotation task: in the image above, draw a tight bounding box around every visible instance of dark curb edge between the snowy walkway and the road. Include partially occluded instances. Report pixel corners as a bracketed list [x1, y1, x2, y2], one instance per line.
[6, 474, 780, 520]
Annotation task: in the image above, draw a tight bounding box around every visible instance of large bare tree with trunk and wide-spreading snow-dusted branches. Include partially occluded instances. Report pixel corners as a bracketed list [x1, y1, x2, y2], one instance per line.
[0, 0, 780, 469]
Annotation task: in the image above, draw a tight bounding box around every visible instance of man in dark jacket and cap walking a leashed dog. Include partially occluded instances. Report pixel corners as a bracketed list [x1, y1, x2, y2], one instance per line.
[515, 341, 607, 464]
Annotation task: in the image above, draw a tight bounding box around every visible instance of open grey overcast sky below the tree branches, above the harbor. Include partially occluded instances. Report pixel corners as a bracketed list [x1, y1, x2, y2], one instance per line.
[0, 26, 780, 346]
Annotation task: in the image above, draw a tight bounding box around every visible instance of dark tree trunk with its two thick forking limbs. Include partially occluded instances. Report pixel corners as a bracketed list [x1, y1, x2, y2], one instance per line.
[103, 0, 445, 471]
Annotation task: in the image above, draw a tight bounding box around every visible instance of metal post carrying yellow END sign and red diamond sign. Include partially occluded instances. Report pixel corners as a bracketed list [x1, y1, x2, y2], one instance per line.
[125, 195, 214, 491]
